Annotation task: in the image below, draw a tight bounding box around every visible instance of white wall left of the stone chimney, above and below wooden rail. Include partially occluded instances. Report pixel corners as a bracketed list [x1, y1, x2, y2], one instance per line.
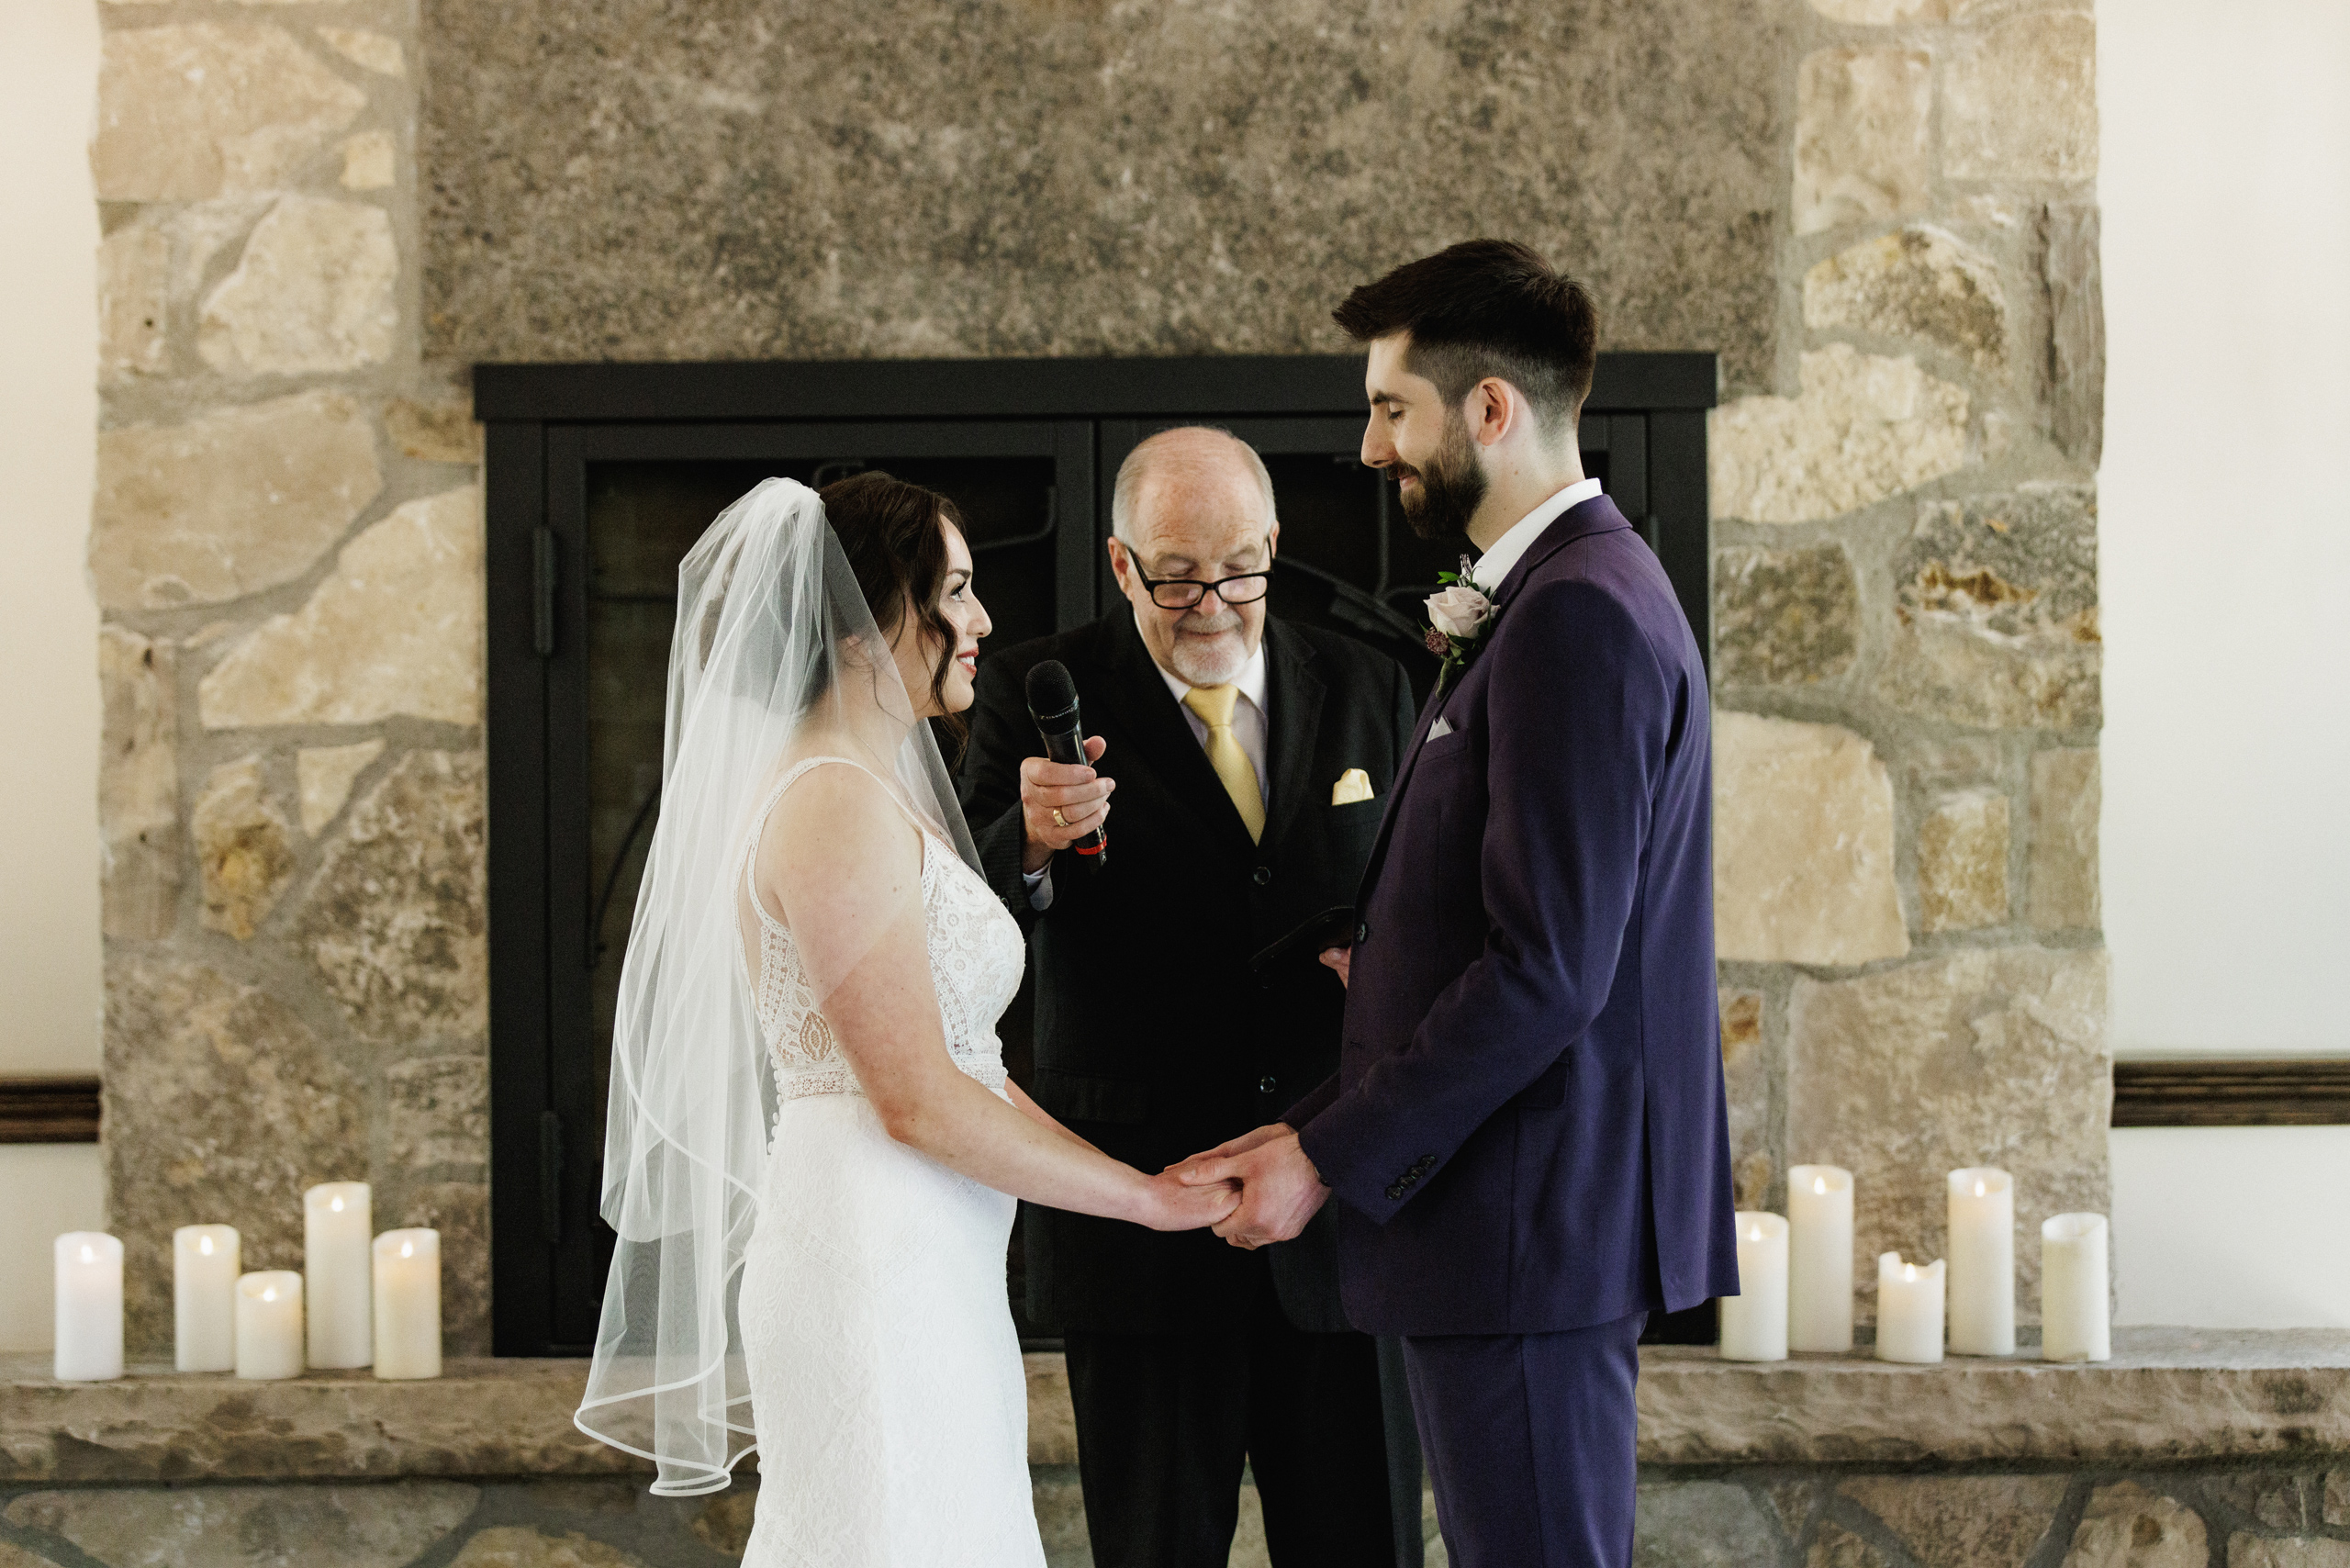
[0, 0, 104, 1350]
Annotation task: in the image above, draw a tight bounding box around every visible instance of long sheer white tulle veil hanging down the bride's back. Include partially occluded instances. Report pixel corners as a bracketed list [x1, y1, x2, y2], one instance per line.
[574, 479, 978, 1495]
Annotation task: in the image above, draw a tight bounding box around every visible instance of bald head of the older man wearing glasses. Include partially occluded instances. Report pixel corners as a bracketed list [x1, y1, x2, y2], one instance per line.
[1109, 425, 1281, 687]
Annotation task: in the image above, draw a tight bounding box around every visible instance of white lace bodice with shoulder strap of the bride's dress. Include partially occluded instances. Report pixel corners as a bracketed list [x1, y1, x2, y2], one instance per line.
[743, 757, 1027, 1100]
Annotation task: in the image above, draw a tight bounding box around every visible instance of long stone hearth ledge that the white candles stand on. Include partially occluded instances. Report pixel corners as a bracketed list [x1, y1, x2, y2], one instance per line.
[0, 1328, 2350, 1484]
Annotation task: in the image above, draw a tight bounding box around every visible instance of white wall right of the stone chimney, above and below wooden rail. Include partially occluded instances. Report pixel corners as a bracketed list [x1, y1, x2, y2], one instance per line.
[2098, 0, 2350, 1326]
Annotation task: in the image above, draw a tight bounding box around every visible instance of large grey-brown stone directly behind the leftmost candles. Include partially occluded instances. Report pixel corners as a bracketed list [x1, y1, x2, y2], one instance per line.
[106, 959, 369, 1350]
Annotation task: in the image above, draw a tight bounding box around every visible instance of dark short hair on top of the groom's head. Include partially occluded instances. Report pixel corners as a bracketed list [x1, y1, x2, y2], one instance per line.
[1330, 240, 1600, 428]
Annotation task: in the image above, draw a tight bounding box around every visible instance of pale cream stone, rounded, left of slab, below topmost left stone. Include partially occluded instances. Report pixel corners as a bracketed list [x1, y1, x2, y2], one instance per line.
[195, 196, 399, 376]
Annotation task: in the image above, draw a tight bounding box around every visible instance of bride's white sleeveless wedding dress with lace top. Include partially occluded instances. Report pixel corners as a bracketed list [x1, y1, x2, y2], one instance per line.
[738, 757, 1044, 1568]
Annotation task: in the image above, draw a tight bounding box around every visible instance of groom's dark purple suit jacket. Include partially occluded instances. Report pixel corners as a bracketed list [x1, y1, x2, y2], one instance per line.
[1285, 496, 1737, 1335]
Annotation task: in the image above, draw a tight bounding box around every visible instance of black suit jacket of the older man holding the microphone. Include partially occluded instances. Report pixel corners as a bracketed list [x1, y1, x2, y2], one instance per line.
[961, 602, 1415, 1333]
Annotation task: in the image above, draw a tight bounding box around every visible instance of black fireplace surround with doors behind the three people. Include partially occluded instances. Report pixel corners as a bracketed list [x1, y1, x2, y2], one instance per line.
[475, 353, 1716, 1357]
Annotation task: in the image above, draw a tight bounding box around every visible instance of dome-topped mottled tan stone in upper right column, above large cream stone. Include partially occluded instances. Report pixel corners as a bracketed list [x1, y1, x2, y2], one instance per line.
[1803, 223, 2007, 369]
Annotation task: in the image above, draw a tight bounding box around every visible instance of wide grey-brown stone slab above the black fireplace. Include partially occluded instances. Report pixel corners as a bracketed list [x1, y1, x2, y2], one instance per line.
[420, 0, 1793, 386]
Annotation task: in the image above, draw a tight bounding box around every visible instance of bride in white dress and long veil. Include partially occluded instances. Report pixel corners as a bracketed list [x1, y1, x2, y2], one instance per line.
[576, 473, 1237, 1568]
